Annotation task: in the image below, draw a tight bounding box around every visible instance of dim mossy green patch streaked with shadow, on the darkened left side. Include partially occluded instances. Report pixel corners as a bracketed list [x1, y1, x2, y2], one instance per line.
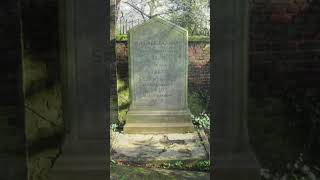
[23, 51, 64, 180]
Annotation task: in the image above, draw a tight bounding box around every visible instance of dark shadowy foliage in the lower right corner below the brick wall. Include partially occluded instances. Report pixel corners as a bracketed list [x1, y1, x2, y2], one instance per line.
[249, 85, 320, 177]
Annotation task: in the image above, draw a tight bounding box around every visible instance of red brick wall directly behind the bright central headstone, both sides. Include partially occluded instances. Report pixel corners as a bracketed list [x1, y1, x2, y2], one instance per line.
[116, 41, 210, 92]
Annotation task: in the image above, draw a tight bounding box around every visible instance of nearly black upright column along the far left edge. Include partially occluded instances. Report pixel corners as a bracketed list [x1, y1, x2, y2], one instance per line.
[0, 0, 27, 180]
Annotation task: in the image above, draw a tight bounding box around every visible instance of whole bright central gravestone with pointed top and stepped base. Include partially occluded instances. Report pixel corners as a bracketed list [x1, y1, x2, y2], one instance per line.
[124, 17, 194, 134]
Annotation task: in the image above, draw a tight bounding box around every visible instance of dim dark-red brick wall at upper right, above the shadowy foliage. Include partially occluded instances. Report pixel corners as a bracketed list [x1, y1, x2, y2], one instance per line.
[250, 0, 320, 95]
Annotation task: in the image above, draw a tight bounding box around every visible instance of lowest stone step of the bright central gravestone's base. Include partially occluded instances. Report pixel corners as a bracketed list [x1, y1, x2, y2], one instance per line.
[123, 122, 195, 134]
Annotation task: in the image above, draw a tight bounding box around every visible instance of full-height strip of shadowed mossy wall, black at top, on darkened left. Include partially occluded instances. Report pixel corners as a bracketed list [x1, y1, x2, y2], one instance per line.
[21, 0, 64, 180]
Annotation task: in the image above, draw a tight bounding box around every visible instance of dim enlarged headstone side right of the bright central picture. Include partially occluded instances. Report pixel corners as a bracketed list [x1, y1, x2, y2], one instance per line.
[211, 0, 260, 180]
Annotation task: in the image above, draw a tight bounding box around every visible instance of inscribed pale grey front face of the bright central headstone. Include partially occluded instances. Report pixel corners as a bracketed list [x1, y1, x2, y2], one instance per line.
[130, 18, 187, 109]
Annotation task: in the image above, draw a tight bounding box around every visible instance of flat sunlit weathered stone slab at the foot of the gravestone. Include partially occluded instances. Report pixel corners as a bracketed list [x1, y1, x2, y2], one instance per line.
[111, 132, 208, 162]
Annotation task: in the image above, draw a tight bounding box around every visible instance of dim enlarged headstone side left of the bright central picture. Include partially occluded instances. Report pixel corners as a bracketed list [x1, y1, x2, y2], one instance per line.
[50, 0, 110, 180]
